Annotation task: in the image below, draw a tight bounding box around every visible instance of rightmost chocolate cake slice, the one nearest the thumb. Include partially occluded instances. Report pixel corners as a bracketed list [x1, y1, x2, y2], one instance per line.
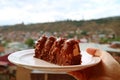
[58, 39, 81, 65]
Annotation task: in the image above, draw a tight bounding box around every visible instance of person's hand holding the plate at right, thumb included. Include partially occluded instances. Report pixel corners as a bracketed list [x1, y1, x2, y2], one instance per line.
[68, 48, 120, 80]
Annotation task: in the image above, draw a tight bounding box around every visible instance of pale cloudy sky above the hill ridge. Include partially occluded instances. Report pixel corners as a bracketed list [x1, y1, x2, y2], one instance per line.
[0, 0, 120, 25]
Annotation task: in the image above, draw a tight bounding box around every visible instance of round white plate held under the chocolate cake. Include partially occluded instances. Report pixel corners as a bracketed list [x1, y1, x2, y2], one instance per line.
[8, 49, 101, 72]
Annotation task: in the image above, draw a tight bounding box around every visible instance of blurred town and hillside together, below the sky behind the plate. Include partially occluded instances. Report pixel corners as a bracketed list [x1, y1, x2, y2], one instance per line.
[0, 16, 120, 80]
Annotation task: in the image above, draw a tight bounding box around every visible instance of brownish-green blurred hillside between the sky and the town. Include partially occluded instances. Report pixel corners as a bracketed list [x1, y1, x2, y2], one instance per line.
[0, 16, 120, 36]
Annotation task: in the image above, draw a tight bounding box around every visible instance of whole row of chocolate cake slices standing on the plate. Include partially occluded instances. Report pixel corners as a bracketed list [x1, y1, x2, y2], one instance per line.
[34, 36, 81, 65]
